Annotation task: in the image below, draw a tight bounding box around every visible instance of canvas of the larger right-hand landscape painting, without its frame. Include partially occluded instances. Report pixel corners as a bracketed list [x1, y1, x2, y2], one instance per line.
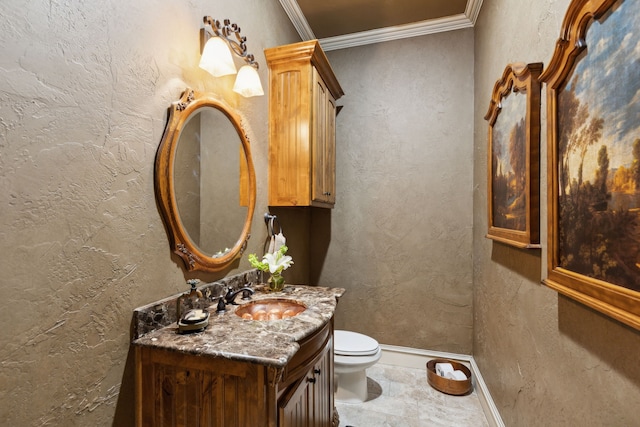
[558, 1, 640, 291]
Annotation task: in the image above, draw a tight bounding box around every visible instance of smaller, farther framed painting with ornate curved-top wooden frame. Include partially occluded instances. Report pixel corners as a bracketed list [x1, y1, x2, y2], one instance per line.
[484, 63, 542, 249]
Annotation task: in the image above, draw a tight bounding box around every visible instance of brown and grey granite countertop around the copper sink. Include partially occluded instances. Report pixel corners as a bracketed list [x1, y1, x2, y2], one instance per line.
[132, 285, 344, 368]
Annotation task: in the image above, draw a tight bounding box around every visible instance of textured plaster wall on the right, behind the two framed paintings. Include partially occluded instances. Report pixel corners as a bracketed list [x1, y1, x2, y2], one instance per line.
[473, 0, 640, 426]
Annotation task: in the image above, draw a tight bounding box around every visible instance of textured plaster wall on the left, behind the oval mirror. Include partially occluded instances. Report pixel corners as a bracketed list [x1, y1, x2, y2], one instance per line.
[0, 0, 299, 426]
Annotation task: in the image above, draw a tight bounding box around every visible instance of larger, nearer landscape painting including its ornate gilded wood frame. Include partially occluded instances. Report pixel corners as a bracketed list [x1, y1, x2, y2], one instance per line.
[540, 0, 640, 329]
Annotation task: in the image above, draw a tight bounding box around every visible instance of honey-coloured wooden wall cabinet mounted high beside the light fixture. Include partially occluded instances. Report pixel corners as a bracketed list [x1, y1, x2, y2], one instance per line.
[265, 40, 344, 208]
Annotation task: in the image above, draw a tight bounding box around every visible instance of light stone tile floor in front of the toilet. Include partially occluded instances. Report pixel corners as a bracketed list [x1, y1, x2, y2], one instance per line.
[336, 363, 489, 427]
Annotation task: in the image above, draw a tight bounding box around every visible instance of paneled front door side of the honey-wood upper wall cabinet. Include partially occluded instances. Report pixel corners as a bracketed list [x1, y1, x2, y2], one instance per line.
[311, 68, 336, 205]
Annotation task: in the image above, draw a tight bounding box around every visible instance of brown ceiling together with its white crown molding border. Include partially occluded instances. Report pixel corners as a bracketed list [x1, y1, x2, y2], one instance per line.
[280, 0, 482, 50]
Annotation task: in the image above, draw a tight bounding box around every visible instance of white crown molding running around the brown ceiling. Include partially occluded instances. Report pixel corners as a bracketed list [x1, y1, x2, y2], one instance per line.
[280, 0, 482, 51]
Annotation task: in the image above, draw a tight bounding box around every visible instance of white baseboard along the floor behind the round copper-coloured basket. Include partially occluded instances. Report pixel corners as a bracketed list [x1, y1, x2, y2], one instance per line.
[379, 344, 504, 427]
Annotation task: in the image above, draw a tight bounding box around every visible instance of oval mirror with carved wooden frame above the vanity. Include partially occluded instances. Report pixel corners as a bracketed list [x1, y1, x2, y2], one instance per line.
[155, 89, 256, 271]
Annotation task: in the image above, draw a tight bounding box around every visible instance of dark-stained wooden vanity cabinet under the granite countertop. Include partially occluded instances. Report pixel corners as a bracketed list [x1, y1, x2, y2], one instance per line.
[135, 319, 334, 427]
